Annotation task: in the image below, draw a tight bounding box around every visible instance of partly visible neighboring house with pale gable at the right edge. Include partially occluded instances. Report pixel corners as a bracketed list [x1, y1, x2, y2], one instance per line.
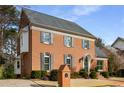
[112, 37, 124, 73]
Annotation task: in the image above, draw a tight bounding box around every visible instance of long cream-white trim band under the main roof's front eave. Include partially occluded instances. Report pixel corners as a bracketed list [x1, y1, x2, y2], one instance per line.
[31, 26, 95, 41]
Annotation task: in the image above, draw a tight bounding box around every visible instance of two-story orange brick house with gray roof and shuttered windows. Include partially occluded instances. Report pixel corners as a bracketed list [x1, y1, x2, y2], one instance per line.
[18, 9, 108, 75]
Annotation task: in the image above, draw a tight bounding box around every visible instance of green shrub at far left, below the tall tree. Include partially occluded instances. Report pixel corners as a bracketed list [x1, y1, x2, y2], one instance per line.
[4, 64, 15, 79]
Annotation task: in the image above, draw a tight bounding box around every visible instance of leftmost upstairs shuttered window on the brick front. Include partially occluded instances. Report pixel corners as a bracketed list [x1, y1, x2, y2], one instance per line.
[41, 32, 52, 44]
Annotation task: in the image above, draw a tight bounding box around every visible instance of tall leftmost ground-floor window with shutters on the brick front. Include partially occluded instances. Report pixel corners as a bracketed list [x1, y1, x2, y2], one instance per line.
[42, 53, 51, 71]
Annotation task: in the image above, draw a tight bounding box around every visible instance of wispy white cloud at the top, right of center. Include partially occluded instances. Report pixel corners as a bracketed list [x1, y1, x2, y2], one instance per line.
[73, 5, 101, 16]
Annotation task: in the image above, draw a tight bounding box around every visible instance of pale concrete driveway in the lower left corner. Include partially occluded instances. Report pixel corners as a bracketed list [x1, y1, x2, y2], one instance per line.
[0, 79, 39, 87]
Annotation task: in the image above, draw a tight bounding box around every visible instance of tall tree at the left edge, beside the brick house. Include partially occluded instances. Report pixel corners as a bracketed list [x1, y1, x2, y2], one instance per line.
[0, 5, 19, 64]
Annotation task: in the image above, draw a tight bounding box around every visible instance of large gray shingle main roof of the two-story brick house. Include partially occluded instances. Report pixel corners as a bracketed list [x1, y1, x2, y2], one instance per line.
[22, 8, 95, 38]
